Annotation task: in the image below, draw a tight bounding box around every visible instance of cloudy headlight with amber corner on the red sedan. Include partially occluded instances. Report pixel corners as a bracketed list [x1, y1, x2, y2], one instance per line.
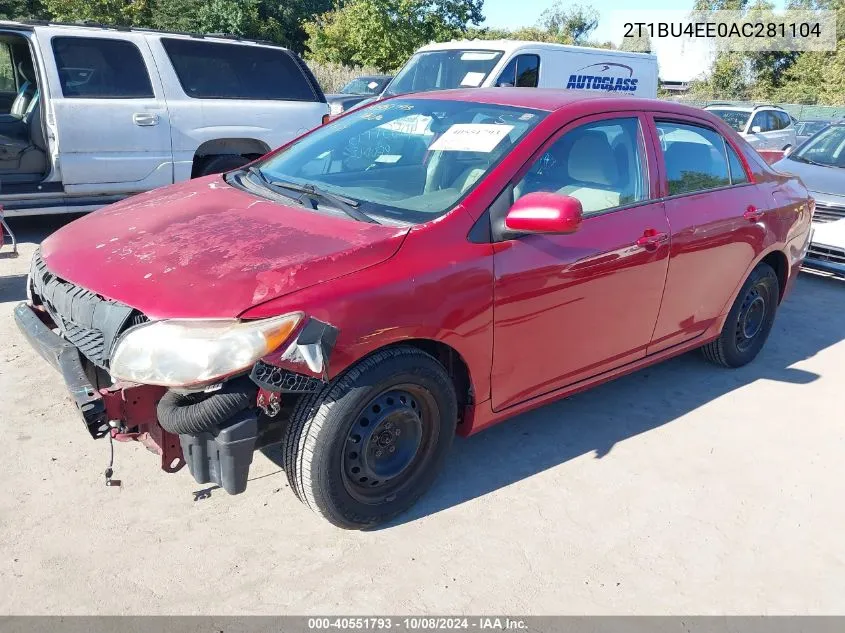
[109, 312, 302, 387]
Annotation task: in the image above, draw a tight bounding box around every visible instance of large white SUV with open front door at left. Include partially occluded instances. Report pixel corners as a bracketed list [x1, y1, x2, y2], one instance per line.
[0, 21, 329, 216]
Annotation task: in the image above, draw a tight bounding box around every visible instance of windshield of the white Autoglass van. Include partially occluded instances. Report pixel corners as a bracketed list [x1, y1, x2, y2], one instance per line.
[385, 50, 504, 95]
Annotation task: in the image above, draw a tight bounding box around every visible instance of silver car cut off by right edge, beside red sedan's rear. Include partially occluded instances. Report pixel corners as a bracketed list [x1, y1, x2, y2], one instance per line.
[773, 121, 845, 275]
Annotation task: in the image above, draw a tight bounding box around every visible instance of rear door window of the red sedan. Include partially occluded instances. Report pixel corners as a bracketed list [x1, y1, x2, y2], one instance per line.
[656, 121, 731, 196]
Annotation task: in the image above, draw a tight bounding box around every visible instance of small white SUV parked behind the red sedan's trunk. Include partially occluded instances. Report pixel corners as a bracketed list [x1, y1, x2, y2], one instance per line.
[704, 104, 795, 150]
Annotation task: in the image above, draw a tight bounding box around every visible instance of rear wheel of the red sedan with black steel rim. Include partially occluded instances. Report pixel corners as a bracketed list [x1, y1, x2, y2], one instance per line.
[701, 263, 780, 367]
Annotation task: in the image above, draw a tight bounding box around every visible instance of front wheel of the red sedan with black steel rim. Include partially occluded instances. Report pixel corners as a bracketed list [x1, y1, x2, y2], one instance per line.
[284, 346, 458, 529]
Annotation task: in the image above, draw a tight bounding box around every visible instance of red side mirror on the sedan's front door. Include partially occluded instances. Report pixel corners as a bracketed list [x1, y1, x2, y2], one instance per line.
[505, 191, 583, 234]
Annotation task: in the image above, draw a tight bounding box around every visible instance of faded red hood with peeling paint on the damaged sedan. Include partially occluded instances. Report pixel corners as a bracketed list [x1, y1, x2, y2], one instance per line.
[41, 176, 409, 318]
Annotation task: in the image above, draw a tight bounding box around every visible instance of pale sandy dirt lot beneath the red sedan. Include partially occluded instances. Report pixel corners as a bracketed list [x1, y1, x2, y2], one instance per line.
[0, 220, 845, 614]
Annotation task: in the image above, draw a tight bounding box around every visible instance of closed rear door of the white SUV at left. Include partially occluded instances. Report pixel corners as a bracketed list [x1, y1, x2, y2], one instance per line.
[38, 27, 173, 194]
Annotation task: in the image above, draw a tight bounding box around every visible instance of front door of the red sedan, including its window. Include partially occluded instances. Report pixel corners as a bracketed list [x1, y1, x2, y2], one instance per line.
[492, 113, 670, 411]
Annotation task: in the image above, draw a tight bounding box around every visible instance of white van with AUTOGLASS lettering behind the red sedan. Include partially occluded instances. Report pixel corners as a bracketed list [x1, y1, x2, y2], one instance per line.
[384, 40, 657, 98]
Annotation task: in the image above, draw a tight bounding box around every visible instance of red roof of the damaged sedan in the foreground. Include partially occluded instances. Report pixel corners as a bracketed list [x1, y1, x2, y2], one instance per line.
[406, 88, 717, 119]
